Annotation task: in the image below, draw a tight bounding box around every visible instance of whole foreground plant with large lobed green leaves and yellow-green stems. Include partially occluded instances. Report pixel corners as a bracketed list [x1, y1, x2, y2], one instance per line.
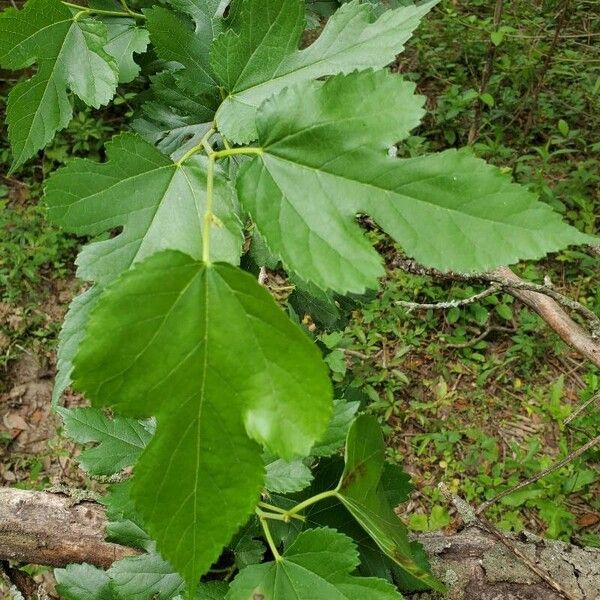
[0, 0, 594, 600]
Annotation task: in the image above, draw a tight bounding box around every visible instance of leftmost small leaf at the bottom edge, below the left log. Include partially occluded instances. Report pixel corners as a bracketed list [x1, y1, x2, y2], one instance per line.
[54, 563, 115, 600]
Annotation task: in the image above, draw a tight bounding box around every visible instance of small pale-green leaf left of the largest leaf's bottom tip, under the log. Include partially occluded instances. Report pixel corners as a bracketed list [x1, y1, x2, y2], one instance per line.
[107, 552, 184, 600]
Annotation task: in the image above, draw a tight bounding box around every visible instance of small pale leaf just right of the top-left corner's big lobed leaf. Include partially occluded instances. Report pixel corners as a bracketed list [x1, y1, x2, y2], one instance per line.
[103, 17, 150, 83]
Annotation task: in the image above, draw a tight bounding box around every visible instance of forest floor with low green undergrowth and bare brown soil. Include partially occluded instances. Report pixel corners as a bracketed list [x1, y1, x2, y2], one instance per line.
[0, 1, 600, 592]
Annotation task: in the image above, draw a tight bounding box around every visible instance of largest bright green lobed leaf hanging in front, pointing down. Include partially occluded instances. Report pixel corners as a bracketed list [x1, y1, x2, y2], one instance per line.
[74, 251, 331, 585]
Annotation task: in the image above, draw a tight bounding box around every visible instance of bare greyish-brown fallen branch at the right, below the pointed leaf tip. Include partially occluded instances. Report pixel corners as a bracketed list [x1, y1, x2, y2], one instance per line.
[392, 257, 600, 367]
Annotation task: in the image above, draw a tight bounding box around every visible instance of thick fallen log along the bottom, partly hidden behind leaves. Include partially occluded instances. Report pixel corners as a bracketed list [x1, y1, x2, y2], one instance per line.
[0, 488, 600, 600]
